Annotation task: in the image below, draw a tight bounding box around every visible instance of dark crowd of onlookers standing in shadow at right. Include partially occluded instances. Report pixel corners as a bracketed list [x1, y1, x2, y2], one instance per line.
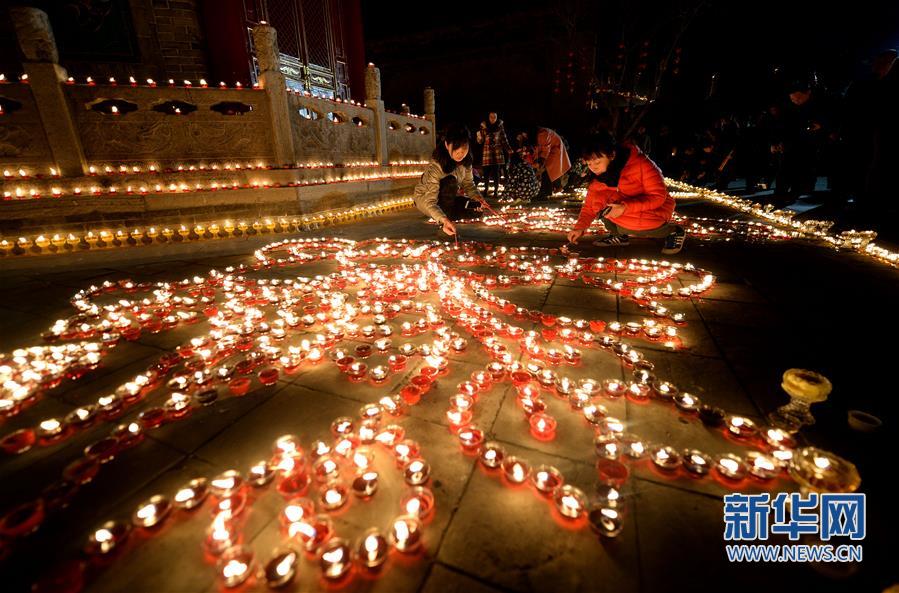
[632, 50, 899, 221]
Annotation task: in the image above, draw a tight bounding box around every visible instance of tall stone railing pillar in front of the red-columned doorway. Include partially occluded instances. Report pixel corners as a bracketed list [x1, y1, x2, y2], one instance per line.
[253, 23, 297, 165]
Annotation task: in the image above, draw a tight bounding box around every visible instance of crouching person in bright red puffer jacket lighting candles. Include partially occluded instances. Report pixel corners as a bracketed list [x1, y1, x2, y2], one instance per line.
[568, 133, 686, 255]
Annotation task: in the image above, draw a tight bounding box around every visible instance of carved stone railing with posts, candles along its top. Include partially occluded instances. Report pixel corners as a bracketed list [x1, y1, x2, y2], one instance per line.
[0, 7, 434, 177]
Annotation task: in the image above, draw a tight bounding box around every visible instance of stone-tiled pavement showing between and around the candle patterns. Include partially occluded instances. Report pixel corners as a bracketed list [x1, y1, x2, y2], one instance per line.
[0, 204, 899, 593]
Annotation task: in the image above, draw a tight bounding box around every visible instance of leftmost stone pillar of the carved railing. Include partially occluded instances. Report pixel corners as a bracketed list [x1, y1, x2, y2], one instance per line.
[9, 6, 88, 177]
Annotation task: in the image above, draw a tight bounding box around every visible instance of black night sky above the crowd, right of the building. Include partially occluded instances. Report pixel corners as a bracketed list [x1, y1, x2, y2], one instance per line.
[363, 0, 899, 134]
